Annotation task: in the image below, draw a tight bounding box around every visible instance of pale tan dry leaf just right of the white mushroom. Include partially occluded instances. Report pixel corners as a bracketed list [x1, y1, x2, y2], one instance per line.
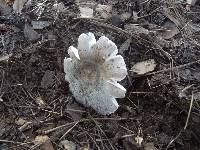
[131, 59, 156, 74]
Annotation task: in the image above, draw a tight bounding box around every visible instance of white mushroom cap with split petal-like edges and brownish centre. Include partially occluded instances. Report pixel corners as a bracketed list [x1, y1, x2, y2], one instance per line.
[64, 32, 127, 115]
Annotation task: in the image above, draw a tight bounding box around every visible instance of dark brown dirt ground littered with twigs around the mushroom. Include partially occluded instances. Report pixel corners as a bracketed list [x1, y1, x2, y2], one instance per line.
[0, 0, 200, 150]
